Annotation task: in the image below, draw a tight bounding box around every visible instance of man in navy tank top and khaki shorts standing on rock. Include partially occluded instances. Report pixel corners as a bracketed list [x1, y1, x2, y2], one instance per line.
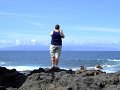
[50, 24, 65, 68]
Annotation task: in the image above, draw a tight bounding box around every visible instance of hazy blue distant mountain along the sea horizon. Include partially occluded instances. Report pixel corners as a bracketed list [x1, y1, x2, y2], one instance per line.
[0, 45, 120, 51]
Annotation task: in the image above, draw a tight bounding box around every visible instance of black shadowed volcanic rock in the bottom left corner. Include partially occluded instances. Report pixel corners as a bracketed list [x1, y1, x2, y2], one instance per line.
[0, 67, 26, 90]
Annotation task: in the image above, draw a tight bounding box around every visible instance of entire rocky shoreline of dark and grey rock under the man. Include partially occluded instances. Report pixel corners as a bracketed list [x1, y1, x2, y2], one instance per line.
[0, 67, 120, 90]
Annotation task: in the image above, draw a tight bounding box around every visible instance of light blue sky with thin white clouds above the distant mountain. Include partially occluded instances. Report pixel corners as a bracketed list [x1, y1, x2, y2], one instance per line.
[0, 0, 120, 48]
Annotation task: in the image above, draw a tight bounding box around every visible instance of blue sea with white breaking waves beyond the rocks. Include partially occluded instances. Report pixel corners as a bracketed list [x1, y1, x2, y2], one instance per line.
[0, 51, 120, 73]
